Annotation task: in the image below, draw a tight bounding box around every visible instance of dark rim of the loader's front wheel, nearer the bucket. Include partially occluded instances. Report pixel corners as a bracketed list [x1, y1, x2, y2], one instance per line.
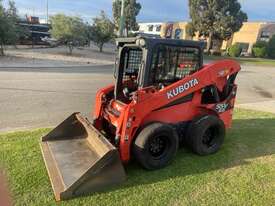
[149, 136, 169, 159]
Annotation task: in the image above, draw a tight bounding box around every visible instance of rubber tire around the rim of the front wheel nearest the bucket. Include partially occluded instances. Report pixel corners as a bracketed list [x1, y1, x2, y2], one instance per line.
[133, 123, 179, 170]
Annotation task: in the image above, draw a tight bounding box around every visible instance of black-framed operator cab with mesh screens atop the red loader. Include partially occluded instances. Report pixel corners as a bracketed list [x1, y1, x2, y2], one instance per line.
[115, 37, 203, 103]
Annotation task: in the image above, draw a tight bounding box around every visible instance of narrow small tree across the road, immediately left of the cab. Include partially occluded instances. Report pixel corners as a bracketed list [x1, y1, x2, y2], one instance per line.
[89, 11, 114, 52]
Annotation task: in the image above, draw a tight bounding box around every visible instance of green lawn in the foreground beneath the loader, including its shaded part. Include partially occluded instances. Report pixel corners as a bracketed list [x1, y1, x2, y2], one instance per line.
[0, 110, 275, 206]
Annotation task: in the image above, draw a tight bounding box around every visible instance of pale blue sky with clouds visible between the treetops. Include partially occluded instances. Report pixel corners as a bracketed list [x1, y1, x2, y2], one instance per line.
[3, 0, 275, 22]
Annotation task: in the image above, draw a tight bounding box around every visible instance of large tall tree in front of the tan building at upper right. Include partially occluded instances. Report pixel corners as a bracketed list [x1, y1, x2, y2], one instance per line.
[189, 0, 247, 52]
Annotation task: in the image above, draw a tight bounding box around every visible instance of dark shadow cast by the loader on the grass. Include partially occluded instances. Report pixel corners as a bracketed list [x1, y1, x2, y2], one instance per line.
[122, 118, 275, 190]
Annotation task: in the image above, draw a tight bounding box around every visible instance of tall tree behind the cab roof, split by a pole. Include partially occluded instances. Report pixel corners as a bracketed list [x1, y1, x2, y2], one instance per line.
[113, 0, 141, 36]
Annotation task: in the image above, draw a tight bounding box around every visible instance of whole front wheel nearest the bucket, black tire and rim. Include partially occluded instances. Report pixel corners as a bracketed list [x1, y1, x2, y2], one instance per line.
[133, 123, 179, 170]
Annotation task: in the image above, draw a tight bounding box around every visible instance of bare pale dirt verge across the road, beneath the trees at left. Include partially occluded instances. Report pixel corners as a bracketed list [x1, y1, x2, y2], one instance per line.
[0, 44, 115, 67]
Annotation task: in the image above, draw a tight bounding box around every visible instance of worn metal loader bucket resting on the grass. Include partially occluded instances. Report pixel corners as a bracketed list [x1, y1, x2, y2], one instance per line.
[41, 113, 126, 201]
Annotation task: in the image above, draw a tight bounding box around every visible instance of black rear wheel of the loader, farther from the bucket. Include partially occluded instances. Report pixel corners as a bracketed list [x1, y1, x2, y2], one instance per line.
[186, 115, 225, 156]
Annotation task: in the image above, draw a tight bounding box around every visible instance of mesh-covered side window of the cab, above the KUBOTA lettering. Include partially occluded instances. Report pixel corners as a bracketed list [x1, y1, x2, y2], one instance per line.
[151, 45, 200, 84]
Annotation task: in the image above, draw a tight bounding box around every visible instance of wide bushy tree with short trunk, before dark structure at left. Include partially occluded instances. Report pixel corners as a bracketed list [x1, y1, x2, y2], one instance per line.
[50, 14, 88, 55]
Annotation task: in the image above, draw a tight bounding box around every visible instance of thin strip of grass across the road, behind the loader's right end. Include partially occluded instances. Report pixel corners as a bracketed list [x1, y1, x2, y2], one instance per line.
[204, 56, 275, 67]
